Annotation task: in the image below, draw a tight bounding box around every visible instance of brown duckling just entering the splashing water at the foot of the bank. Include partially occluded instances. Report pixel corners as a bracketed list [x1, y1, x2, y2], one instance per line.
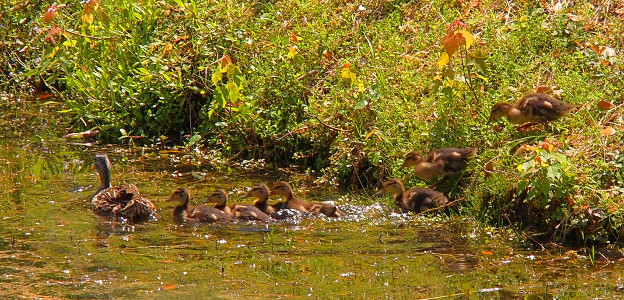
[376, 178, 448, 213]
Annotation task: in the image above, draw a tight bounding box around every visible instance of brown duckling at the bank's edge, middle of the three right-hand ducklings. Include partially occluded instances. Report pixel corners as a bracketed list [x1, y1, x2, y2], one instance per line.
[401, 148, 477, 180]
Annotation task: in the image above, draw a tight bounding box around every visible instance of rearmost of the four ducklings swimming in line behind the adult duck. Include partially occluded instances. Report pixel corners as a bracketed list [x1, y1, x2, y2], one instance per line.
[270, 181, 344, 217]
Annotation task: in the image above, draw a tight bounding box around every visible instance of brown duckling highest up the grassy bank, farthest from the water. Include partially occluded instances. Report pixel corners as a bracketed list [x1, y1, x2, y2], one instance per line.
[489, 93, 576, 125]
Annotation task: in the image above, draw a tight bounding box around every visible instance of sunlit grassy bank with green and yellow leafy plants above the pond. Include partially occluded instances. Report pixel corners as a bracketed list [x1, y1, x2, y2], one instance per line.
[0, 0, 624, 242]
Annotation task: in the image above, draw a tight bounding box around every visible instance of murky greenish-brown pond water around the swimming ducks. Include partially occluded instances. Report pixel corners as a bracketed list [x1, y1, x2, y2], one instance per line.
[0, 98, 624, 299]
